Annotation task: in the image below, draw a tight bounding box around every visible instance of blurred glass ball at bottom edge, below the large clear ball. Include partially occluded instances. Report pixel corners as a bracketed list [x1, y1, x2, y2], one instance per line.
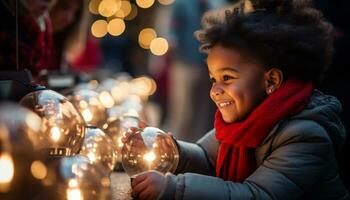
[38, 155, 111, 200]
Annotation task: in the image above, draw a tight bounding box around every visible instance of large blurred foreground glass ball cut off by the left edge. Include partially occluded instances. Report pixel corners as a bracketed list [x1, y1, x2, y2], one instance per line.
[0, 103, 47, 200]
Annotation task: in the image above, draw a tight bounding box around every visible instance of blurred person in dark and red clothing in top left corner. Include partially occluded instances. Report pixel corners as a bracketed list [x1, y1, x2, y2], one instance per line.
[0, 0, 56, 77]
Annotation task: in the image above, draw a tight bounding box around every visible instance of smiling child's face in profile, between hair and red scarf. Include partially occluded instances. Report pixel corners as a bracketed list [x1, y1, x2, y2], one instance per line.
[207, 45, 266, 123]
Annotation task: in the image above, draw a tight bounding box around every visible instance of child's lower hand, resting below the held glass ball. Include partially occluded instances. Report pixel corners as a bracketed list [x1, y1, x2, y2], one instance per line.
[131, 170, 166, 200]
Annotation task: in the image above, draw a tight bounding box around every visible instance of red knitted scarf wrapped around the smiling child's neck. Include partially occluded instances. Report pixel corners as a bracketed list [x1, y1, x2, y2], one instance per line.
[214, 80, 313, 182]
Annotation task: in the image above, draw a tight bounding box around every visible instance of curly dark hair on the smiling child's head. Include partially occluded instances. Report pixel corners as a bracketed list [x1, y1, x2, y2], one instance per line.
[195, 0, 334, 83]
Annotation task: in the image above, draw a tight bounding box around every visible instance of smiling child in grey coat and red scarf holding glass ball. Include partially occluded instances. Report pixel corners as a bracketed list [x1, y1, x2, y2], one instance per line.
[132, 0, 349, 199]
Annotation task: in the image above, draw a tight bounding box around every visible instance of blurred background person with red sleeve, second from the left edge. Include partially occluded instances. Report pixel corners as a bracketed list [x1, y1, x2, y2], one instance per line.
[50, 0, 101, 72]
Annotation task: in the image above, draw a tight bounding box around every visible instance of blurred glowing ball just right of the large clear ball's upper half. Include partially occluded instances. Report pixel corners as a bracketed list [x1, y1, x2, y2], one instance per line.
[67, 89, 107, 128]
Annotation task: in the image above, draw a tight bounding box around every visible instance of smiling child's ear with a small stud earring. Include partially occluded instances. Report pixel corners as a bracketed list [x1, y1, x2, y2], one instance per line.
[264, 68, 283, 95]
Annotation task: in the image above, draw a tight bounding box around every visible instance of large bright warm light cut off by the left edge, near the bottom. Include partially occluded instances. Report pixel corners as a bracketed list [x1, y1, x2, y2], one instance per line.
[0, 153, 15, 184]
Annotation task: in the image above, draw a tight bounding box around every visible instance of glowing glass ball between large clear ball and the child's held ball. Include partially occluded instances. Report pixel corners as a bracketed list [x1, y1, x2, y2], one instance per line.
[80, 126, 117, 174]
